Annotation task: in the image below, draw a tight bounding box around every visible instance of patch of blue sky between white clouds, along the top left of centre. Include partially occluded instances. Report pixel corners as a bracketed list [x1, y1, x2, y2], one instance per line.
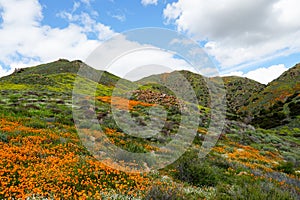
[40, 0, 174, 32]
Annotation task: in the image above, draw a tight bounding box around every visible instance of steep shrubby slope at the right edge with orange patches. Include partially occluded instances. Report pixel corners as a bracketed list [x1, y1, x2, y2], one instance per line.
[239, 64, 300, 128]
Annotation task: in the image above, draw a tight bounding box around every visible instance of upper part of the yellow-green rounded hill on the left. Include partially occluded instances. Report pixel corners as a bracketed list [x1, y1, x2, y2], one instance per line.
[0, 59, 132, 92]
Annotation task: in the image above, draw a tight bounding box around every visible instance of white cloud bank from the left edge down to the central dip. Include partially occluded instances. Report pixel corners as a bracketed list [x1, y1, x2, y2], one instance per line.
[0, 0, 195, 79]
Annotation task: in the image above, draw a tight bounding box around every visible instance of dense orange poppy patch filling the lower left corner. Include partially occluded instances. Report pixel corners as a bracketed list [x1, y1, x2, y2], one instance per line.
[0, 118, 149, 199]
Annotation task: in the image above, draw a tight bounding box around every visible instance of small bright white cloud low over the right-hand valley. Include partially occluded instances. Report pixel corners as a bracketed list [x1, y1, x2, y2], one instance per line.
[222, 64, 288, 84]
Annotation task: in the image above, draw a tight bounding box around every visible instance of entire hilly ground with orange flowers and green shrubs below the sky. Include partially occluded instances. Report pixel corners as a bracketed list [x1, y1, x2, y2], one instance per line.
[0, 59, 300, 200]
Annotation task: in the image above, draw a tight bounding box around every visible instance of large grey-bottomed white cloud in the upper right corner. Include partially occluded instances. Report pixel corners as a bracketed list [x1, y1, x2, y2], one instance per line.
[164, 0, 300, 69]
